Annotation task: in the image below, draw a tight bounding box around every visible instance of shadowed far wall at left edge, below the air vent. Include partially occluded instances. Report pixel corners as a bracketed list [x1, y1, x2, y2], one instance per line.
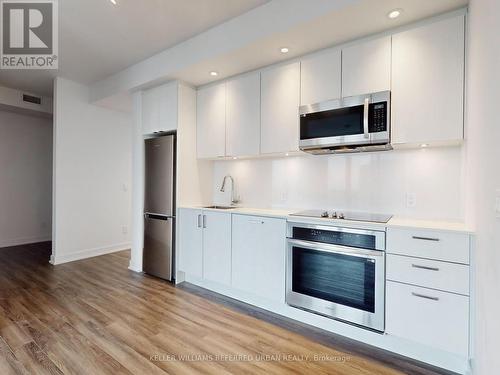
[0, 111, 52, 247]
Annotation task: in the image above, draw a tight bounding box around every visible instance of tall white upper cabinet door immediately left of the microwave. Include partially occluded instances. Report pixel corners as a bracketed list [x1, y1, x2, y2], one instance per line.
[261, 62, 300, 154]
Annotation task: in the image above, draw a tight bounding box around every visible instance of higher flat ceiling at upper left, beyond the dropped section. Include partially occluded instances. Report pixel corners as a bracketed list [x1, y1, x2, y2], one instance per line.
[0, 0, 269, 95]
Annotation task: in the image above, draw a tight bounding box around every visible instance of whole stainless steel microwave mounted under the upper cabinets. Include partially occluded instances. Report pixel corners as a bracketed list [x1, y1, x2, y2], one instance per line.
[299, 91, 392, 155]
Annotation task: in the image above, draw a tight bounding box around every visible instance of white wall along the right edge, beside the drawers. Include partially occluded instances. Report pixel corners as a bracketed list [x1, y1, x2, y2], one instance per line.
[467, 0, 500, 375]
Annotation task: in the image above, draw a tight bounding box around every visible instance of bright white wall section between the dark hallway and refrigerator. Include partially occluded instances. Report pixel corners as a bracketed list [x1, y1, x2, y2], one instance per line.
[52, 78, 132, 264]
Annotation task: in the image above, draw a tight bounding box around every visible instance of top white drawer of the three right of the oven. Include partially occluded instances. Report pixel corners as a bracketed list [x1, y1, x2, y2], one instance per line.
[387, 228, 469, 264]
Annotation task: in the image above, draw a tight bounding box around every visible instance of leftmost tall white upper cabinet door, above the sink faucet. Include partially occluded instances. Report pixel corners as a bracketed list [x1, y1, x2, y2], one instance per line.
[196, 83, 226, 158]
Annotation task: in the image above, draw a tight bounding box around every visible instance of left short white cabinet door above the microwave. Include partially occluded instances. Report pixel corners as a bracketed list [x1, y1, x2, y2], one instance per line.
[300, 48, 342, 105]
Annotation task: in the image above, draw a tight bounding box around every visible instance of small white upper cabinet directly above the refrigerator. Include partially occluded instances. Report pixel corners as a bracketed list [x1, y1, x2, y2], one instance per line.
[142, 82, 179, 134]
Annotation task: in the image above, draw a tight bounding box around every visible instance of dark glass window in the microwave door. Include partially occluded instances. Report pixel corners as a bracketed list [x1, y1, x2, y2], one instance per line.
[300, 105, 364, 140]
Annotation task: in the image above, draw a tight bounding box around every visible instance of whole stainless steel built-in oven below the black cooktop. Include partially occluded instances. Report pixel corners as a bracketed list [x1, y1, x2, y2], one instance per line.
[286, 222, 385, 332]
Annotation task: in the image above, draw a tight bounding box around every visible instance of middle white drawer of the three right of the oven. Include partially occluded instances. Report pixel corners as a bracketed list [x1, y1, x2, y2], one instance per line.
[386, 254, 469, 296]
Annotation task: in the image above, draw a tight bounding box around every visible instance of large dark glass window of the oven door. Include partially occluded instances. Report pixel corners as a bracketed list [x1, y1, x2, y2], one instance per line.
[292, 247, 375, 313]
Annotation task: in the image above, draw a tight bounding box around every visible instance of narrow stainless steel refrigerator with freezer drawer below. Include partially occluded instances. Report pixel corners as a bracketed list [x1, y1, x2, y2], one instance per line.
[143, 135, 175, 281]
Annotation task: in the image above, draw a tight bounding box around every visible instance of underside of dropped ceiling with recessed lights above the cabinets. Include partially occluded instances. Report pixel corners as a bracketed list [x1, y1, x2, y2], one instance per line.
[177, 0, 468, 86]
